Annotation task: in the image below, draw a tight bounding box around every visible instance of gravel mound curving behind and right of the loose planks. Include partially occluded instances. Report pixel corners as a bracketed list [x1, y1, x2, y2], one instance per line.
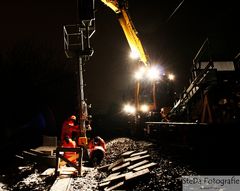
[97, 138, 196, 191]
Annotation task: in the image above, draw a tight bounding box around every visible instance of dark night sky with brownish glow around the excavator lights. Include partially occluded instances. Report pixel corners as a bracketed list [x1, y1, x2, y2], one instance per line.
[0, 0, 240, 117]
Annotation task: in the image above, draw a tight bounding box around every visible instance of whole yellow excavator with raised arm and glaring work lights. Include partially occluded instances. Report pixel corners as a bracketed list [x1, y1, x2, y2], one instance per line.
[97, 0, 178, 139]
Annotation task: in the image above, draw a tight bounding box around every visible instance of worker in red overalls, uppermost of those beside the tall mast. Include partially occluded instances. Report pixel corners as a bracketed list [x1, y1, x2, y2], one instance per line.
[61, 115, 78, 144]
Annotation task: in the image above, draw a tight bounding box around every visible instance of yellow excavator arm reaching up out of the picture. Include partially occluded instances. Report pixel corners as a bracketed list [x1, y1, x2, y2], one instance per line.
[101, 0, 149, 66]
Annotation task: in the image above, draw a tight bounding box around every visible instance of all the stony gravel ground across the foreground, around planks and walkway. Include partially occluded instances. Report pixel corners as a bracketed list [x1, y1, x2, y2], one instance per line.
[0, 138, 196, 191]
